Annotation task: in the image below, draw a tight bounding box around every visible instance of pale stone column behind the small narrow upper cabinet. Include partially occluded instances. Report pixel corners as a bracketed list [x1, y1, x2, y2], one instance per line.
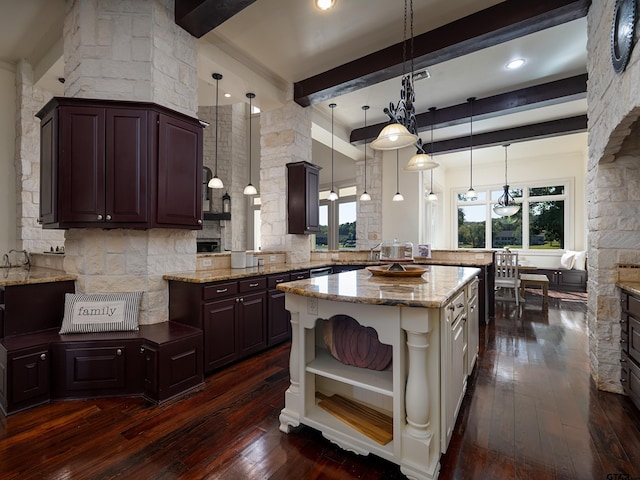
[260, 97, 311, 262]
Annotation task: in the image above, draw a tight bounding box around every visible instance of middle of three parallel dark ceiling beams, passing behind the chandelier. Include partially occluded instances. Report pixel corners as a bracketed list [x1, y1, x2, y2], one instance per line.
[349, 73, 587, 145]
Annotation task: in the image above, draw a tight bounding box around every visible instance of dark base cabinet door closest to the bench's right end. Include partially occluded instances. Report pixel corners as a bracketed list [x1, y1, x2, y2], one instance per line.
[202, 298, 238, 373]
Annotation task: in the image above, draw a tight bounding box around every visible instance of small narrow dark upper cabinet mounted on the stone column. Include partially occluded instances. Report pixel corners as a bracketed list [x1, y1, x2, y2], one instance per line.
[287, 162, 320, 234]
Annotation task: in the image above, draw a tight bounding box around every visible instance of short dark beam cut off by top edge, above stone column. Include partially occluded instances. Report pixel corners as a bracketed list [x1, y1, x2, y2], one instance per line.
[175, 0, 256, 38]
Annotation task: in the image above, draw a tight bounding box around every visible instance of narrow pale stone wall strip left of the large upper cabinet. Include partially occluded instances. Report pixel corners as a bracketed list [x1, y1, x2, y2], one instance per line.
[14, 60, 64, 252]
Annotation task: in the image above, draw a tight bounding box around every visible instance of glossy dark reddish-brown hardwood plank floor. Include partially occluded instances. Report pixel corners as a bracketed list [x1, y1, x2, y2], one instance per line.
[0, 299, 640, 480]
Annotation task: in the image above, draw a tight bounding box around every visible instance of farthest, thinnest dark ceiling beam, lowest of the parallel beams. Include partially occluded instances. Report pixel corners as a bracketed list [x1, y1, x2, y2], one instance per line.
[426, 115, 587, 154]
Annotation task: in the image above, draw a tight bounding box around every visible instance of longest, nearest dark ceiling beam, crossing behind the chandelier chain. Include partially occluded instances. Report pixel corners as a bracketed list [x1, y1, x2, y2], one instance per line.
[294, 0, 591, 107]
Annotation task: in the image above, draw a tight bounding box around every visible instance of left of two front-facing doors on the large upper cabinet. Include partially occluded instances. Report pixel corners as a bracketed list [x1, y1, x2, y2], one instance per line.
[58, 106, 105, 224]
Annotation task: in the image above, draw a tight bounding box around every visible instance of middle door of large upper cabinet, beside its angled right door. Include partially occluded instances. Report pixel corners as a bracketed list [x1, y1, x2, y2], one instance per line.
[104, 108, 149, 223]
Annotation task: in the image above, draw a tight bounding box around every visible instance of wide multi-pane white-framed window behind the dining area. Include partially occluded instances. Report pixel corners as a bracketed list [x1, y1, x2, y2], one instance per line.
[456, 179, 573, 250]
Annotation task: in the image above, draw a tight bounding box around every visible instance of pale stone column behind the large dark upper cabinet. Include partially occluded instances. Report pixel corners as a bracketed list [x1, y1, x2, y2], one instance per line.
[64, 0, 198, 324]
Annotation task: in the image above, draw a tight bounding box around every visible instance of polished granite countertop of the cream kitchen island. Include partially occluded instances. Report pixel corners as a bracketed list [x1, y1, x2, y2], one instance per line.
[276, 265, 480, 308]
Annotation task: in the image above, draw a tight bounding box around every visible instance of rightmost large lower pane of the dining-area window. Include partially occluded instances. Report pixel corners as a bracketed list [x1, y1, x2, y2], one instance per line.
[529, 201, 564, 249]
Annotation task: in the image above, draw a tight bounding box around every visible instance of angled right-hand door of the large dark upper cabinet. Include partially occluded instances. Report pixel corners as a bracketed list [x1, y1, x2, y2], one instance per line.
[157, 114, 202, 227]
